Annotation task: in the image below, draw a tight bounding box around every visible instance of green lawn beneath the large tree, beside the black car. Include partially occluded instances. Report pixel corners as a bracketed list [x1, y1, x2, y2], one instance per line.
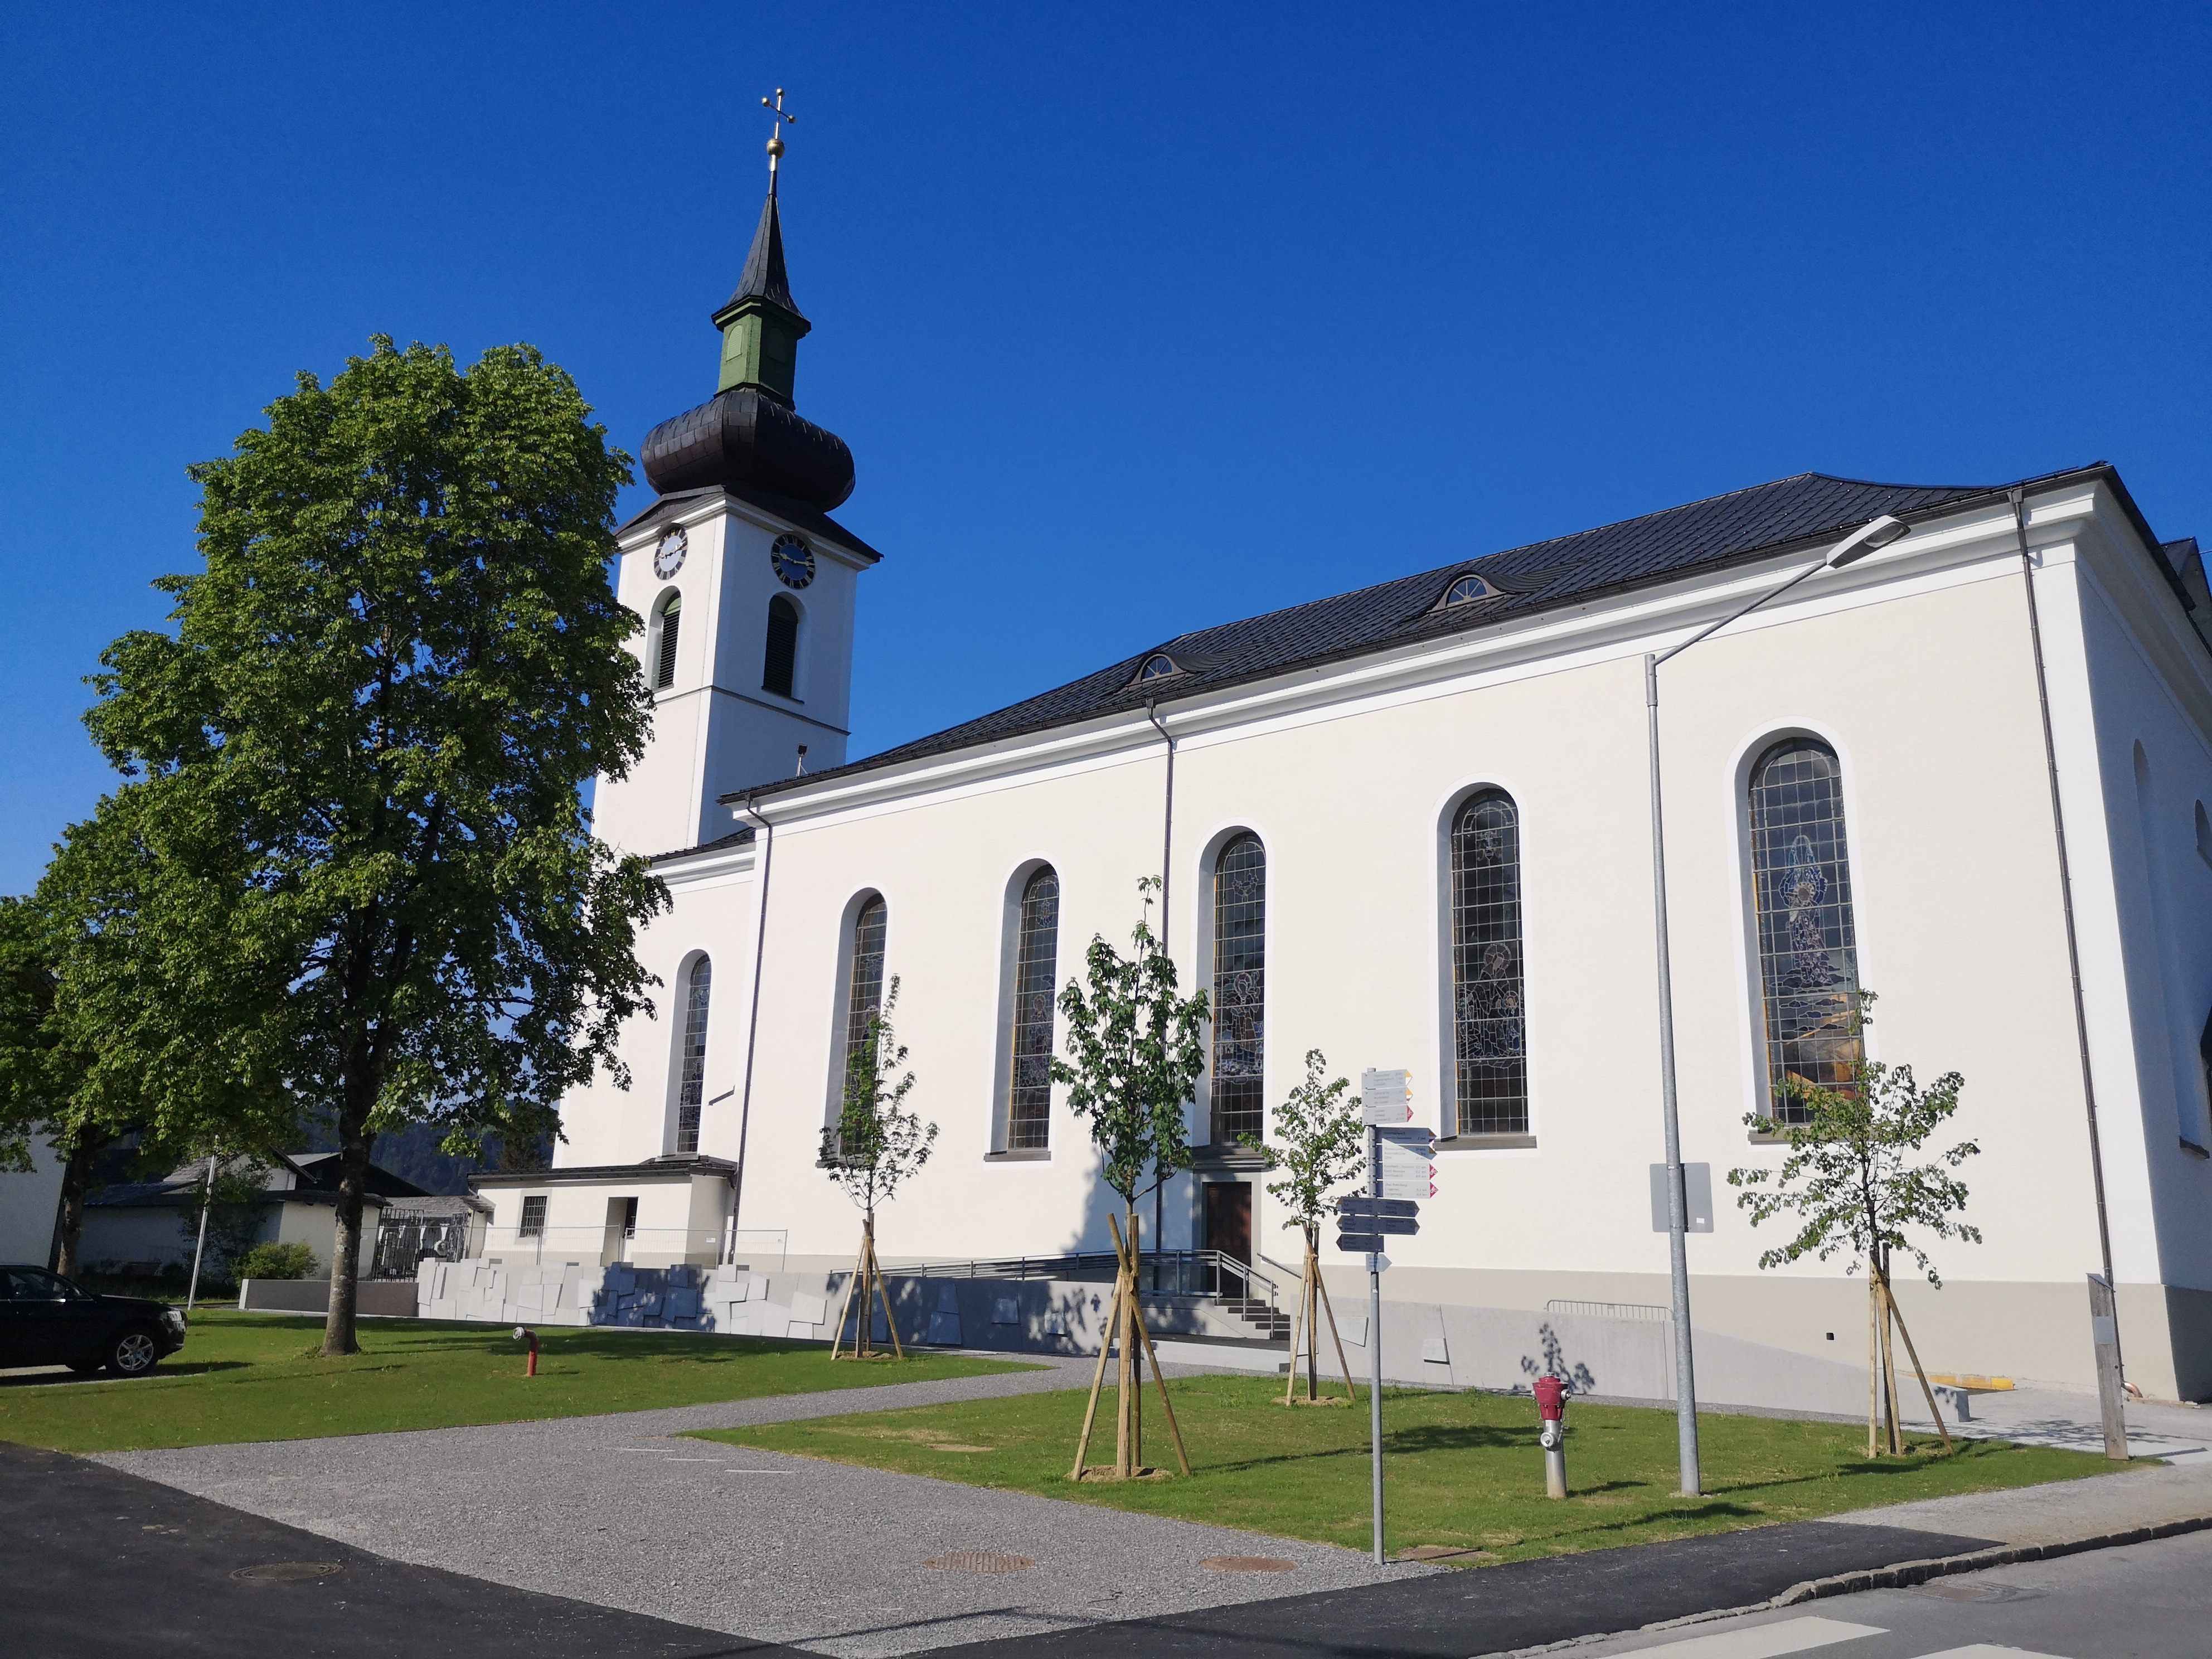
[0, 1309, 1026, 1451]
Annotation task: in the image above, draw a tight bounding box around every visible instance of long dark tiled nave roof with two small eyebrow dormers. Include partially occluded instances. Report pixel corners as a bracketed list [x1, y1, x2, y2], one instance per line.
[717, 469, 2082, 814]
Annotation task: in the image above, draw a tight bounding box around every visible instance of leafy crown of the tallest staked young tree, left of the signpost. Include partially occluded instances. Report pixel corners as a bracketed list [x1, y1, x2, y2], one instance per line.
[1053, 876, 1208, 1230]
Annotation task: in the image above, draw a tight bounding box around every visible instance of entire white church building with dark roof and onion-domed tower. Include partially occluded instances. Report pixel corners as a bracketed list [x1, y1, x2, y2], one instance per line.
[482, 179, 2212, 1398]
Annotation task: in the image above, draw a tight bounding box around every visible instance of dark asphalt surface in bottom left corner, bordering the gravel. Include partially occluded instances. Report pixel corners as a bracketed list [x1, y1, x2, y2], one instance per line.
[0, 1442, 796, 1659]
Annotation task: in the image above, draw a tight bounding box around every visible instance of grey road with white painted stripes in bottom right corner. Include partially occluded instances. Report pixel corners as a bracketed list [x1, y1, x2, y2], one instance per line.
[1555, 1533, 2212, 1659]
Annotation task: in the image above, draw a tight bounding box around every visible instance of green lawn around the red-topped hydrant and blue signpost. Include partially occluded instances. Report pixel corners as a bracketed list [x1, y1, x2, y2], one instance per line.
[701, 1376, 2110, 1564]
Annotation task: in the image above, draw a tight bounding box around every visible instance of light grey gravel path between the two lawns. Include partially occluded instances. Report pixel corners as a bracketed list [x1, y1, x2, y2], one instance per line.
[100, 1362, 1438, 1659]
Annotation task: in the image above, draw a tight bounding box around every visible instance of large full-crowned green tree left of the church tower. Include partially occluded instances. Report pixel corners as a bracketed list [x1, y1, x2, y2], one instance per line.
[55, 338, 668, 1354]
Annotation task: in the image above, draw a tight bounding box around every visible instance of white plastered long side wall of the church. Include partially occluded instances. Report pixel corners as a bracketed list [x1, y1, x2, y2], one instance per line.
[564, 489, 2212, 1391]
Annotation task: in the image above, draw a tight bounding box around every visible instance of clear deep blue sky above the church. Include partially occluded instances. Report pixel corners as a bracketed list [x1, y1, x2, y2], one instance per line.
[0, 4, 2212, 891]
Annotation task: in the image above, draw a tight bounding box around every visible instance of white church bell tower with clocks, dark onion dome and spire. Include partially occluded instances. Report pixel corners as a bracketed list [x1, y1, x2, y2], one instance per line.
[593, 89, 882, 854]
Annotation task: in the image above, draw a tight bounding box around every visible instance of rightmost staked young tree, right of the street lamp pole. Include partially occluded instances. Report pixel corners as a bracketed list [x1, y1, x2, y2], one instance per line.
[1728, 991, 1982, 1451]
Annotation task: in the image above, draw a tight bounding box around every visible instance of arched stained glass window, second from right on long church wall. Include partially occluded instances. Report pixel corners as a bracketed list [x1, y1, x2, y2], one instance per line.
[1451, 790, 1529, 1135]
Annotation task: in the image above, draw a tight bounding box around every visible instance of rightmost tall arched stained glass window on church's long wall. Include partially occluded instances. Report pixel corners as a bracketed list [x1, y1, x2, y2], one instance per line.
[1750, 736, 1865, 1124]
